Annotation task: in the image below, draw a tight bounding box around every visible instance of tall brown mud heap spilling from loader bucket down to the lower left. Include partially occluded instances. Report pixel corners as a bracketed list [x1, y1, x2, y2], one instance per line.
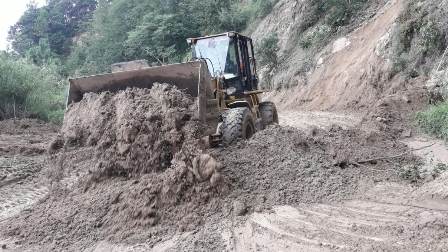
[1, 84, 226, 250]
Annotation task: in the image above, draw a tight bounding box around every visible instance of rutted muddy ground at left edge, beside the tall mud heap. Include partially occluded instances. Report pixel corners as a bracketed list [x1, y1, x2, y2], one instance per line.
[0, 120, 57, 222]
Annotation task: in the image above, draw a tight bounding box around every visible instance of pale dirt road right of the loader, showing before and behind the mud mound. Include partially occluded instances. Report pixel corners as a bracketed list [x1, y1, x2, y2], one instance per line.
[88, 111, 448, 252]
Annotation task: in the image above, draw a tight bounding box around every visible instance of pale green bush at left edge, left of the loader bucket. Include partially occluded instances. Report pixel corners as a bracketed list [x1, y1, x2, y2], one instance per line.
[0, 53, 65, 122]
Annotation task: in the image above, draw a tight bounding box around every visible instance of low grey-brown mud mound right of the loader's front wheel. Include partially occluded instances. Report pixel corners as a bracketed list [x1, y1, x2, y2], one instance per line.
[213, 126, 413, 210]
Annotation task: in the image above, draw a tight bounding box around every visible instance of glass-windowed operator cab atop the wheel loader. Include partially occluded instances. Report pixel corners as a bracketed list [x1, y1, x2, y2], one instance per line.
[188, 32, 258, 97]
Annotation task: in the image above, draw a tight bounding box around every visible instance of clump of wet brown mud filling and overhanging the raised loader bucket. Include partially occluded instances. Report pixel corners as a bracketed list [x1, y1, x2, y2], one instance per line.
[58, 84, 202, 179]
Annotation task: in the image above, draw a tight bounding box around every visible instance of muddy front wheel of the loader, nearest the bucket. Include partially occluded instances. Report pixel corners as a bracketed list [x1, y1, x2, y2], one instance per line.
[221, 108, 256, 145]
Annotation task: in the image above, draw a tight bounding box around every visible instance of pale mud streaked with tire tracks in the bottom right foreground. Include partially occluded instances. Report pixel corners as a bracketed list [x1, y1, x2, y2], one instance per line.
[229, 183, 448, 251]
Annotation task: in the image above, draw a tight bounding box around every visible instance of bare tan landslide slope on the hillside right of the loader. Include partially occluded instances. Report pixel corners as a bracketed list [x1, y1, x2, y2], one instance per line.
[262, 0, 429, 137]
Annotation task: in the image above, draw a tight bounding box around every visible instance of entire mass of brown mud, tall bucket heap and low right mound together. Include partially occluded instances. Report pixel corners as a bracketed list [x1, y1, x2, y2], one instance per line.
[1, 85, 420, 250]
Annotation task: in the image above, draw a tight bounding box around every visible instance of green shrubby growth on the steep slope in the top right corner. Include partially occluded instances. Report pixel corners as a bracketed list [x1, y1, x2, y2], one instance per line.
[392, 0, 448, 77]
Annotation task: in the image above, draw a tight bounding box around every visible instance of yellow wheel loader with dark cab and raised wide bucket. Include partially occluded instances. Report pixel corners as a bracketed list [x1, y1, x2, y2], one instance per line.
[67, 32, 278, 147]
